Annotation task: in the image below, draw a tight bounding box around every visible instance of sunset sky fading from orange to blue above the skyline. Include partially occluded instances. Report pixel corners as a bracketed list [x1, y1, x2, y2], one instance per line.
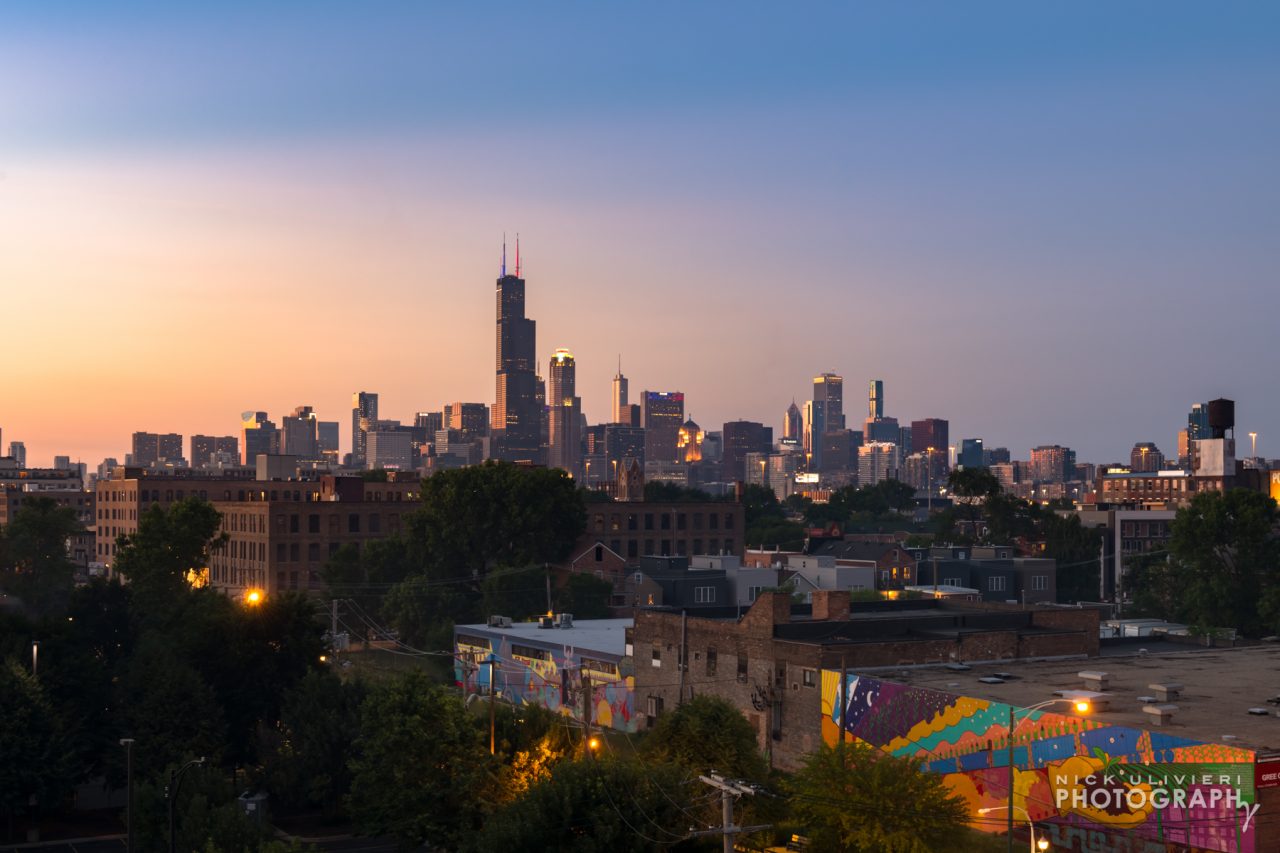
[0, 1, 1280, 466]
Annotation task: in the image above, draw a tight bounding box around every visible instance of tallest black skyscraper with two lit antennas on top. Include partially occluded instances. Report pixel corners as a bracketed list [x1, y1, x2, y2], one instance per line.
[490, 242, 543, 462]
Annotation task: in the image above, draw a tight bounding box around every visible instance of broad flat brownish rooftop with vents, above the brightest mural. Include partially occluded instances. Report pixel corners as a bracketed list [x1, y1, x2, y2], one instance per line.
[867, 640, 1280, 753]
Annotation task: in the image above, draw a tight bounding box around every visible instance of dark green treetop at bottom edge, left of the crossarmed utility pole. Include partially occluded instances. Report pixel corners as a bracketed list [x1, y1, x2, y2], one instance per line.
[465, 757, 696, 853]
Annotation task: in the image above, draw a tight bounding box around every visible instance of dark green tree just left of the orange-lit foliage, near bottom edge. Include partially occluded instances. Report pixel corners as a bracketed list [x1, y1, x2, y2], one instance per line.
[346, 671, 490, 848]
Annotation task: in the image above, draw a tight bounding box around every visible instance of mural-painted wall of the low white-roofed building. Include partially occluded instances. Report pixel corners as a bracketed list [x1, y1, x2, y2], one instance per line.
[453, 633, 637, 731]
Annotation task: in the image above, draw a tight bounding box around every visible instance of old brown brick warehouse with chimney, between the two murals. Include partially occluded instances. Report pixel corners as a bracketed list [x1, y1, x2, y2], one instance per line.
[631, 590, 1098, 770]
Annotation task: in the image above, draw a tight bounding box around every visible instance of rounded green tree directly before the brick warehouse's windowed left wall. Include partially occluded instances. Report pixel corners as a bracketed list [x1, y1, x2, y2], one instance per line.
[644, 694, 769, 780]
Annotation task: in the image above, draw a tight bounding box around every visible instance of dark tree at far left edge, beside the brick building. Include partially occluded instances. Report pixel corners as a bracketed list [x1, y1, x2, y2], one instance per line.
[0, 497, 81, 616]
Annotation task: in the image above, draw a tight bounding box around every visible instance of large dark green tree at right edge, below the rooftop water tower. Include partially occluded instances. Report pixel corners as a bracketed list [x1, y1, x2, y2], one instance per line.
[1130, 489, 1280, 637]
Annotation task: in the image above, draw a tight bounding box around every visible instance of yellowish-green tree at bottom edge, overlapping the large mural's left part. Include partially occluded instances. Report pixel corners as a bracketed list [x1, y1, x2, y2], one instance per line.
[790, 743, 968, 853]
